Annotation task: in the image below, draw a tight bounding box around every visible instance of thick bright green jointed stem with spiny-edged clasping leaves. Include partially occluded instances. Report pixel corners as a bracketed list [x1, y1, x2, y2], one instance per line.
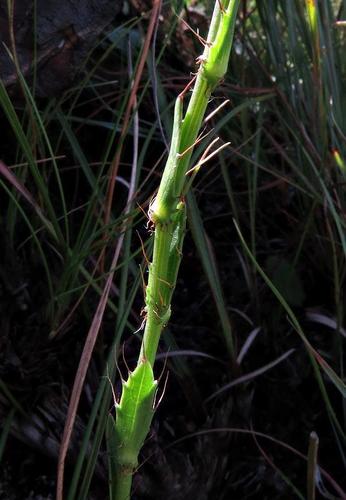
[111, 0, 240, 500]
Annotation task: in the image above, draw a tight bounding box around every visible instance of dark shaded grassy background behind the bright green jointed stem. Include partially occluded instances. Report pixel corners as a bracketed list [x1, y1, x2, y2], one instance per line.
[0, 0, 346, 500]
